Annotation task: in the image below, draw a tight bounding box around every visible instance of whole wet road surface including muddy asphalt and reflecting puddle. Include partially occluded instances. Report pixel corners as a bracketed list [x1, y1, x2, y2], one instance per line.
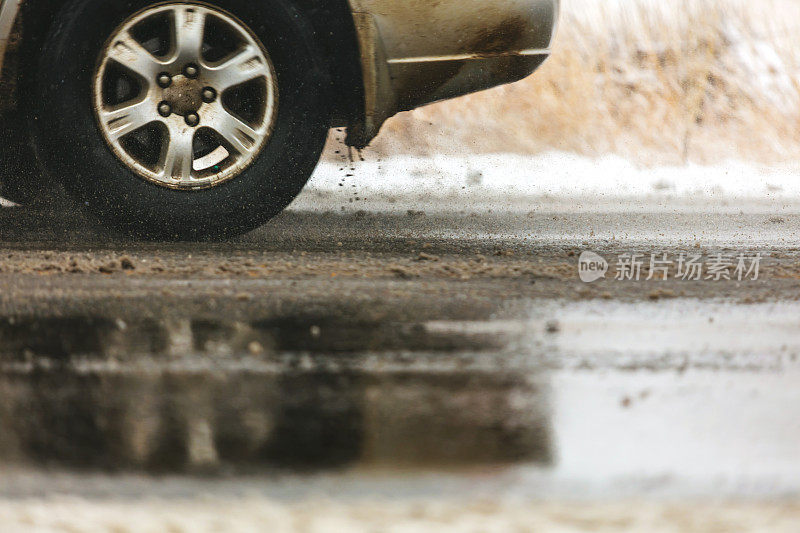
[0, 198, 800, 512]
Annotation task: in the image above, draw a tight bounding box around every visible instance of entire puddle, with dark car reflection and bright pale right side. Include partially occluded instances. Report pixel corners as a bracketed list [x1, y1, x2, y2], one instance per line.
[0, 300, 800, 497]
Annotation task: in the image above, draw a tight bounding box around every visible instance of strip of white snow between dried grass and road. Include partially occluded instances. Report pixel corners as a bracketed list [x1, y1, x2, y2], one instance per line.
[311, 152, 800, 204]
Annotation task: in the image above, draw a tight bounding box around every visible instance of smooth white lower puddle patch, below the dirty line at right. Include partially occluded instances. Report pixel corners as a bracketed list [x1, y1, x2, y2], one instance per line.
[552, 370, 800, 496]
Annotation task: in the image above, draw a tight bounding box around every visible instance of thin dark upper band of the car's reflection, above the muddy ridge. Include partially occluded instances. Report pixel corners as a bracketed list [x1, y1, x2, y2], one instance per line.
[0, 316, 509, 364]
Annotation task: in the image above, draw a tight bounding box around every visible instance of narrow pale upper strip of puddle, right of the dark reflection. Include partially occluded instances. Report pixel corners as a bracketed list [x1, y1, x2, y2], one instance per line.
[523, 299, 800, 371]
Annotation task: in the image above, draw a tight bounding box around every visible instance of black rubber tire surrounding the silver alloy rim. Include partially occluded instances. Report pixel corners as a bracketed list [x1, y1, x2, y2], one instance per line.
[32, 0, 330, 240]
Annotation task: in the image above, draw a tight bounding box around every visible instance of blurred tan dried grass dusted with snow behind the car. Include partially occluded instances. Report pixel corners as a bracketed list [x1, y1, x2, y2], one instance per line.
[346, 0, 800, 164]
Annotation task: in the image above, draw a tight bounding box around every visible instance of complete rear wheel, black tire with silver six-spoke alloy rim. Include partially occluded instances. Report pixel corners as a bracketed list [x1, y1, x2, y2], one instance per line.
[34, 0, 329, 239]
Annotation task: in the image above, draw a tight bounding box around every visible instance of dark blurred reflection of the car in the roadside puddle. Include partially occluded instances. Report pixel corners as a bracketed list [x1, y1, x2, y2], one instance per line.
[0, 317, 552, 471]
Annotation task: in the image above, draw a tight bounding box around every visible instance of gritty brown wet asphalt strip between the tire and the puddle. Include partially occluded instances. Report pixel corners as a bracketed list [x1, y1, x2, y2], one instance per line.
[0, 200, 800, 320]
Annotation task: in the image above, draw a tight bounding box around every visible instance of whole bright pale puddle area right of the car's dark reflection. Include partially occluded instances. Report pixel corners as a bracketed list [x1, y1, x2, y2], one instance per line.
[520, 300, 800, 497]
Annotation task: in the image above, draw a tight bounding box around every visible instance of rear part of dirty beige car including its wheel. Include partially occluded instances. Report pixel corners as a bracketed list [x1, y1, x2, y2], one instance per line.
[0, 0, 559, 240]
